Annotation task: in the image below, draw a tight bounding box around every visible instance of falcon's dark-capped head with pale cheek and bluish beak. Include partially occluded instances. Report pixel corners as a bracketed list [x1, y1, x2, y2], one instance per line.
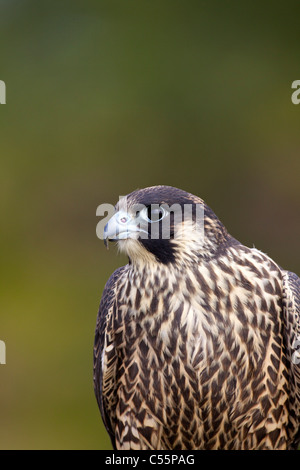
[104, 186, 228, 264]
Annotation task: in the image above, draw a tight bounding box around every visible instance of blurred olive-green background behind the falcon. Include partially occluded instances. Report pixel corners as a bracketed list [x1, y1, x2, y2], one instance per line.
[0, 0, 300, 449]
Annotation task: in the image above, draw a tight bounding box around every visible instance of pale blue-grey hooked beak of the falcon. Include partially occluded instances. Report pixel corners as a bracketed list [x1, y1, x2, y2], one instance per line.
[103, 211, 148, 249]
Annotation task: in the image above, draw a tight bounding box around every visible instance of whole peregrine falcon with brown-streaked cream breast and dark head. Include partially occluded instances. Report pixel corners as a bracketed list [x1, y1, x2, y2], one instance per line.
[94, 186, 300, 450]
